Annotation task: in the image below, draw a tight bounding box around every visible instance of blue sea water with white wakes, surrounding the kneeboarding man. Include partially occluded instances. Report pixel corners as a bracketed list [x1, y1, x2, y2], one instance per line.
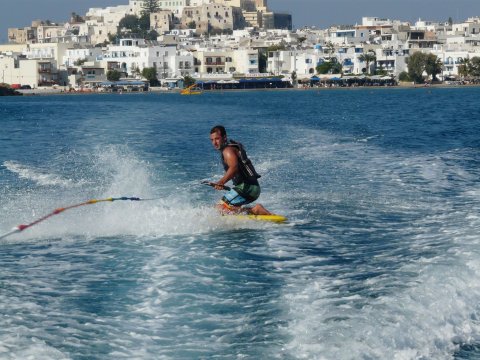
[0, 88, 480, 359]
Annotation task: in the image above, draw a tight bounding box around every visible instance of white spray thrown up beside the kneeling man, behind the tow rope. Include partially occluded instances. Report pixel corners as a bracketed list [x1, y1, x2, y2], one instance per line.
[1, 147, 270, 245]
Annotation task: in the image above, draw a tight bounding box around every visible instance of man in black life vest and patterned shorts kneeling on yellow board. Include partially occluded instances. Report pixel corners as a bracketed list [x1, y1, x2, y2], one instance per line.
[210, 125, 271, 215]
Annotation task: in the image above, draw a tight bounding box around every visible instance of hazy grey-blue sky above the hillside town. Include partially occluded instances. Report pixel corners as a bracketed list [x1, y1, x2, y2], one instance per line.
[0, 0, 480, 43]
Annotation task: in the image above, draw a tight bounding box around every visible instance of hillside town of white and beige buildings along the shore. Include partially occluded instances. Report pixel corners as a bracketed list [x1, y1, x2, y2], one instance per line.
[0, 0, 480, 90]
